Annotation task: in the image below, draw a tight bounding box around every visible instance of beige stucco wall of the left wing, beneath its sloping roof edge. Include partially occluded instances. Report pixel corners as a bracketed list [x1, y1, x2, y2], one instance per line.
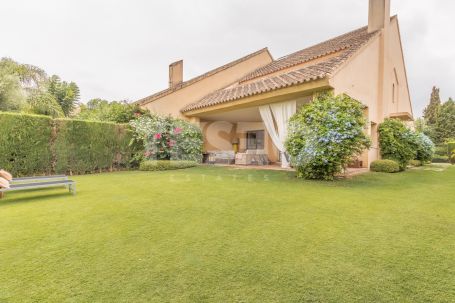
[143, 51, 272, 118]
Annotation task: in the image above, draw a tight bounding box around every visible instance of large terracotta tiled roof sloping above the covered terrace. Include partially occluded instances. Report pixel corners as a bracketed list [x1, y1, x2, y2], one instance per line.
[181, 27, 377, 112]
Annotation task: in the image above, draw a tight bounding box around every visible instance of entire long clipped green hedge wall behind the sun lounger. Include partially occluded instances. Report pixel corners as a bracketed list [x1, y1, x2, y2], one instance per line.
[0, 112, 135, 176]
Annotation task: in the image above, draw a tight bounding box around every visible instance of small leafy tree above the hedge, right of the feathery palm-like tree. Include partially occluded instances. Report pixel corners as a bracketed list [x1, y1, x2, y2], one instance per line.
[47, 75, 80, 117]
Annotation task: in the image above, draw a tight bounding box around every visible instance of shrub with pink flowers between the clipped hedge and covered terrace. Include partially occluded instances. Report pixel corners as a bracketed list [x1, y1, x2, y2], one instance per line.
[130, 115, 203, 162]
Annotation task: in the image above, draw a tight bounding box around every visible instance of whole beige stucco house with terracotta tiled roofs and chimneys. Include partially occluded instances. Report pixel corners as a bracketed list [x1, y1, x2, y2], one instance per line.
[137, 0, 413, 167]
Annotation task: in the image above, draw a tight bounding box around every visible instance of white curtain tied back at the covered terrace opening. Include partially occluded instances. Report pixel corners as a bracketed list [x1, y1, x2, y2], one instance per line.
[259, 100, 297, 168]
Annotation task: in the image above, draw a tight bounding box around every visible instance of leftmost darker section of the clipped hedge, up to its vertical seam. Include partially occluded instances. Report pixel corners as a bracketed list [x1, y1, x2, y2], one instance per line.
[0, 112, 52, 177]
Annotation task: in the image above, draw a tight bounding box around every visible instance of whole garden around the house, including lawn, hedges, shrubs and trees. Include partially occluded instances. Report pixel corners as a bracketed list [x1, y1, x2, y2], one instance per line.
[0, 59, 455, 302]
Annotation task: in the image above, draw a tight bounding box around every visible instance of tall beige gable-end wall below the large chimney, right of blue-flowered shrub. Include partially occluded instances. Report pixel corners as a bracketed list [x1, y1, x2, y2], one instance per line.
[330, 18, 412, 166]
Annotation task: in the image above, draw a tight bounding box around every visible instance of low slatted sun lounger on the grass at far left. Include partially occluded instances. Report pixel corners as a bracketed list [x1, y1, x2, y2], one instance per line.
[0, 175, 76, 197]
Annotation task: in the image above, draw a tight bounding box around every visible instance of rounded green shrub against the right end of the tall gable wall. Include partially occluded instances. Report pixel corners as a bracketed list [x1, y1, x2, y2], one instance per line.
[378, 119, 417, 170]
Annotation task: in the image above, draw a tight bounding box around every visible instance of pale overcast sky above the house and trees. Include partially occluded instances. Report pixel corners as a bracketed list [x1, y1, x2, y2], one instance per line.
[0, 0, 455, 117]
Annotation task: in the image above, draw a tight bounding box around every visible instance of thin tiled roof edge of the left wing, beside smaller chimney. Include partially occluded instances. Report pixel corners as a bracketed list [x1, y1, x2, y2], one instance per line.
[135, 47, 272, 105]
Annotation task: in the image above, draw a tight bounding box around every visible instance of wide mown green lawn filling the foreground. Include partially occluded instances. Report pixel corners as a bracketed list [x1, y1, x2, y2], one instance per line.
[0, 167, 455, 302]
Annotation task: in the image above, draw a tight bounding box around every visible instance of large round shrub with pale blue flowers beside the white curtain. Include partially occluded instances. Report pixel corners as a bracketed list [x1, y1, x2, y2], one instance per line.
[286, 94, 371, 180]
